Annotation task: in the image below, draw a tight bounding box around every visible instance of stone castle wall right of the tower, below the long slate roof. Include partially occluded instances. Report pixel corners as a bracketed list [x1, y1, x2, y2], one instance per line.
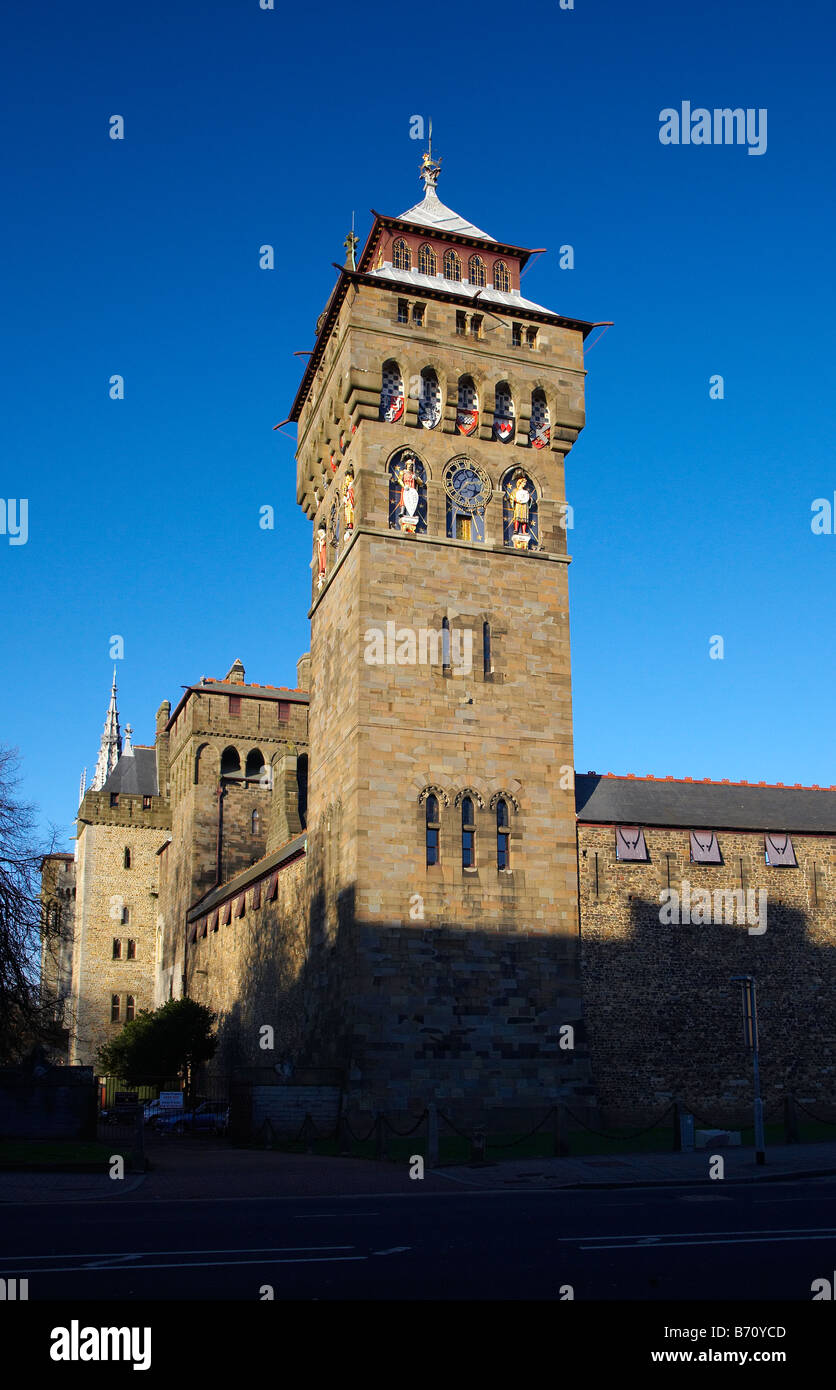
[579, 824, 836, 1123]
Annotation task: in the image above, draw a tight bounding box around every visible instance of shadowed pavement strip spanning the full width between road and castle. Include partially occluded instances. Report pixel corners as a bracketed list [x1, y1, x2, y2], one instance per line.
[0, 1140, 836, 1204]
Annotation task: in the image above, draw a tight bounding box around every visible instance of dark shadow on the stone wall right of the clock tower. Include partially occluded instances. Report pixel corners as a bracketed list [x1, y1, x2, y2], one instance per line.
[581, 898, 836, 1123]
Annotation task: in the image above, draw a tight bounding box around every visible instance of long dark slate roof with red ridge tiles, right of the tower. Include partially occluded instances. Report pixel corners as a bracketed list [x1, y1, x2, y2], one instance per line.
[574, 773, 836, 834]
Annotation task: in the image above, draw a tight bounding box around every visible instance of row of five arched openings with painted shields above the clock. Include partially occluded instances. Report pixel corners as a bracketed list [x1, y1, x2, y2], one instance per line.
[380, 359, 551, 449]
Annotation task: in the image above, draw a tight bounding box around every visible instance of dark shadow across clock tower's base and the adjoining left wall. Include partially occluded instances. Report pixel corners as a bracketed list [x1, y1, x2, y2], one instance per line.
[204, 890, 594, 1118]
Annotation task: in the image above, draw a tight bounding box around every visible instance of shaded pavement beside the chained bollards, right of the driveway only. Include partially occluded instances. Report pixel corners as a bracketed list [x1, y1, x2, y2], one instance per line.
[438, 1143, 836, 1188]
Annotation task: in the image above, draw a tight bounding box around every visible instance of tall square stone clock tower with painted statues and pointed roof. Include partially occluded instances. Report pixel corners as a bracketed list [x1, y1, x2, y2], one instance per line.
[291, 156, 591, 1109]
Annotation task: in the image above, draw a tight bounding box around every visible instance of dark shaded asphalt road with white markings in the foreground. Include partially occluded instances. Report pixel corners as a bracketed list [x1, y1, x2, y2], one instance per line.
[0, 1177, 836, 1302]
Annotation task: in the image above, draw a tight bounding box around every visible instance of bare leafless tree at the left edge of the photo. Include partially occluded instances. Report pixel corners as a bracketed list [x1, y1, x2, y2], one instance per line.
[0, 746, 63, 1065]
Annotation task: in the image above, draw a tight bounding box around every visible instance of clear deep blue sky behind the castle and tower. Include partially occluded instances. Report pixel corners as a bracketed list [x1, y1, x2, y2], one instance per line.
[0, 0, 836, 845]
